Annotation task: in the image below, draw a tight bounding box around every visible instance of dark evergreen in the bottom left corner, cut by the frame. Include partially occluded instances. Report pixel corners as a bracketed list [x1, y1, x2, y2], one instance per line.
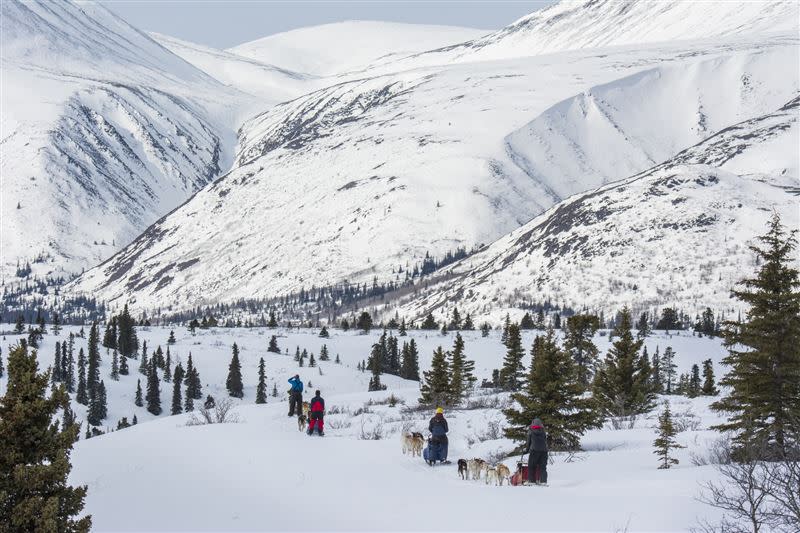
[0, 345, 92, 533]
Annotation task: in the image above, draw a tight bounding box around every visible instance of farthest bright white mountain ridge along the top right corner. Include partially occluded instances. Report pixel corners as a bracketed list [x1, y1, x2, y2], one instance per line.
[360, 0, 800, 72]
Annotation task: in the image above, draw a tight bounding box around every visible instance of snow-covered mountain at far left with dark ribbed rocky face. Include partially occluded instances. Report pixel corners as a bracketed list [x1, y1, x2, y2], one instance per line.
[0, 1, 247, 281]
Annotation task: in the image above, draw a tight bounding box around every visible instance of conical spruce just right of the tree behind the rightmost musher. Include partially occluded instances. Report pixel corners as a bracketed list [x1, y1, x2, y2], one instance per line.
[593, 308, 654, 416]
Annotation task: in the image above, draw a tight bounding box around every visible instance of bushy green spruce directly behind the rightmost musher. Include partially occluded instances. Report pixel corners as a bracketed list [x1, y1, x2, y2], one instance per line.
[503, 328, 600, 450]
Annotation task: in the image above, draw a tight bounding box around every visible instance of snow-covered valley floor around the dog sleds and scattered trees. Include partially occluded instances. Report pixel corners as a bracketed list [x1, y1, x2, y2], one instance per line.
[0, 327, 736, 532]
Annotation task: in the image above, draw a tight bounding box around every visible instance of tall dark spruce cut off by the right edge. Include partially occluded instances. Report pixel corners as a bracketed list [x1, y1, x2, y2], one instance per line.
[711, 214, 800, 456]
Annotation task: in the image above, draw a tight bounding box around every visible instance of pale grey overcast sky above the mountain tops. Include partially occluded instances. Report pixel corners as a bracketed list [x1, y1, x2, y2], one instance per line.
[101, 0, 554, 48]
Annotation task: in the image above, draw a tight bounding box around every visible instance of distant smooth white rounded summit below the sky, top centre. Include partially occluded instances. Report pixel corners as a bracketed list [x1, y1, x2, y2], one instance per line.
[228, 20, 490, 76]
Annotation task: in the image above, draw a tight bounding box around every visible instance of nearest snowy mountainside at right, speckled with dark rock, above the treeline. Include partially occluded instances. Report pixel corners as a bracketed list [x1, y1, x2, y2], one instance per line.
[394, 96, 800, 323]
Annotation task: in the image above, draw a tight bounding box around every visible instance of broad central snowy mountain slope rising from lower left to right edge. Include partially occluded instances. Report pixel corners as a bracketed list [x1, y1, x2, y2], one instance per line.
[70, 29, 798, 309]
